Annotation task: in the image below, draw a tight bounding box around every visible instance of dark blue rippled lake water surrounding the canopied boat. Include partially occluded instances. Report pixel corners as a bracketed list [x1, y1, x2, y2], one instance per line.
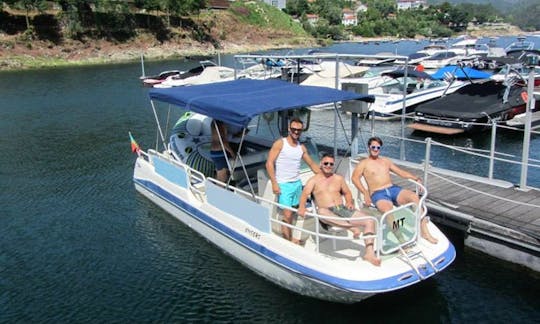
[0, 36, 540, 323]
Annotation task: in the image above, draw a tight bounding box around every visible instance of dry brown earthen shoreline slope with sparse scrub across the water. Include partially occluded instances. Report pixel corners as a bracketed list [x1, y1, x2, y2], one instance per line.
[0, 7, 524, 71]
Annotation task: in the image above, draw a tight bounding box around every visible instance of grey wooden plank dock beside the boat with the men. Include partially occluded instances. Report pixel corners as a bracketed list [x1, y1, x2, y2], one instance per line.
[395, 166, 540, 271]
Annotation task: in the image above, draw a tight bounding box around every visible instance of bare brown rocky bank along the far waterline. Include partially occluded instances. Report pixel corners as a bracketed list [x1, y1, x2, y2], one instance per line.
[0, 17, 523, 70]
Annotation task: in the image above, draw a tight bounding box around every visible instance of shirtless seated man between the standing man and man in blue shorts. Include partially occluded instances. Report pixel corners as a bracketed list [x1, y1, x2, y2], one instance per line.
[298, 154, 381, 266]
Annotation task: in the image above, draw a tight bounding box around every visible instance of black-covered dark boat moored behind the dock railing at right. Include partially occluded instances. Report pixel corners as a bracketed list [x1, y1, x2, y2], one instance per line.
[409, 80, 527, 135]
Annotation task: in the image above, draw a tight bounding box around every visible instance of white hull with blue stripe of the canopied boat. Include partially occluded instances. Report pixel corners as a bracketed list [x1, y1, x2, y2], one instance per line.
[134, 153, 455, 303]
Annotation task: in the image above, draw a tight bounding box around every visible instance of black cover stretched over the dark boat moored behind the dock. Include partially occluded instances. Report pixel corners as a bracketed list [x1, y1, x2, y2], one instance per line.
[415, 81, 527, 120]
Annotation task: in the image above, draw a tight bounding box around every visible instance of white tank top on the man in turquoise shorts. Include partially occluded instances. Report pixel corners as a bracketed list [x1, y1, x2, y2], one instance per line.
[276, 138, 304, 183]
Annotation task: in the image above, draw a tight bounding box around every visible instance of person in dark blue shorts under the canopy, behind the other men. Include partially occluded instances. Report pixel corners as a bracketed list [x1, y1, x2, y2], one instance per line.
[210, 120, 235, 182]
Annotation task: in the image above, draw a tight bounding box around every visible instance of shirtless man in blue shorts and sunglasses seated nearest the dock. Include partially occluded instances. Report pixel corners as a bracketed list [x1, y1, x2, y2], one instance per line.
[352, 137, 437, 244]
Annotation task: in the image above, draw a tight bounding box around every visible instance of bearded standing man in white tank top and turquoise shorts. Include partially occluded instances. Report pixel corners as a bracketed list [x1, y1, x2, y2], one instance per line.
[266, 118, 320, 244]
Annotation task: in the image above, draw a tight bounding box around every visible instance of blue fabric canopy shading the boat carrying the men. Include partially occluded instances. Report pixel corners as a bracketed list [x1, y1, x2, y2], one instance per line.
[149, 79, 375, 127]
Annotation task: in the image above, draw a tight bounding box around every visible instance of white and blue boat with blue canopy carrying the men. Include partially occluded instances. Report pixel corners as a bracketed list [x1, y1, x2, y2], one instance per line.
[132, 79, 456, 303]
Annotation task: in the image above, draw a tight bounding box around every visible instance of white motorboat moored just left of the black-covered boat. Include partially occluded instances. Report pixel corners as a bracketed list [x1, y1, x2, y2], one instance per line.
[369, 68, 467, 120]
